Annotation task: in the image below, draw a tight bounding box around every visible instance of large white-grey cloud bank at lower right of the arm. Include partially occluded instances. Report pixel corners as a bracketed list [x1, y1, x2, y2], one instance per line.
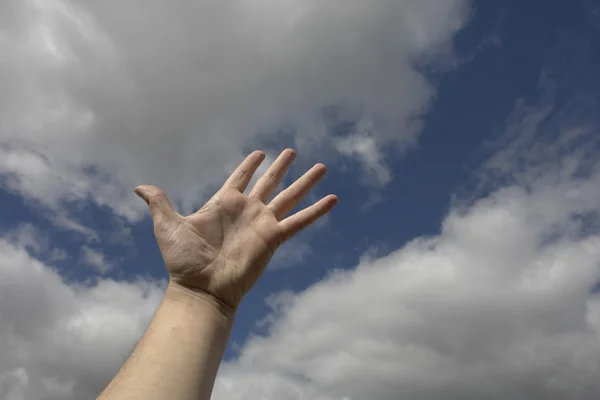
[214, 99, 600, 400]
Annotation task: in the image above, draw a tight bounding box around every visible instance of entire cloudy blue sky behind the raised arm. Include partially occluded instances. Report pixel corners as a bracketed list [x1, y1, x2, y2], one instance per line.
[0, 0, 600, 400]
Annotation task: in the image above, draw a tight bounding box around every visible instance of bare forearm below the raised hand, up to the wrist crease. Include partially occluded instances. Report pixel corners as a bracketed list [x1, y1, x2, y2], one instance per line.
[99, 285, 233, 400]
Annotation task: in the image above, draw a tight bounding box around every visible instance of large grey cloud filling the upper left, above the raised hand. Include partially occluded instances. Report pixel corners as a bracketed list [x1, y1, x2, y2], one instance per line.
[0, 0, 468, 219]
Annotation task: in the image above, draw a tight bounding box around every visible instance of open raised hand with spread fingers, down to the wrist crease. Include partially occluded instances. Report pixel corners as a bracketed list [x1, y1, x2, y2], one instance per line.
[135, 149, 337, 311]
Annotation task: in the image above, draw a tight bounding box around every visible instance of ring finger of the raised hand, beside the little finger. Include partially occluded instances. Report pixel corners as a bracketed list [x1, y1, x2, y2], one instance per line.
[268, 164, 327, 220]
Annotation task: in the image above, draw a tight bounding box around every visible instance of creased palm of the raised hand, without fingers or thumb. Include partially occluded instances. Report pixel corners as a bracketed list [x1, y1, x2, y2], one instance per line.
[157, 190, 282, 304]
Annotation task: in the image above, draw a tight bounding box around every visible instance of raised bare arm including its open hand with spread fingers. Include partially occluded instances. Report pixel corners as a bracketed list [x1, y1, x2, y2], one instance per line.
[99, 150, 337, 400]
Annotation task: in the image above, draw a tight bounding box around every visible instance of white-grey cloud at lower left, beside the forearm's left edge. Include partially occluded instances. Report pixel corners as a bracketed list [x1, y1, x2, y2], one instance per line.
[0, 238, 164, 400]
